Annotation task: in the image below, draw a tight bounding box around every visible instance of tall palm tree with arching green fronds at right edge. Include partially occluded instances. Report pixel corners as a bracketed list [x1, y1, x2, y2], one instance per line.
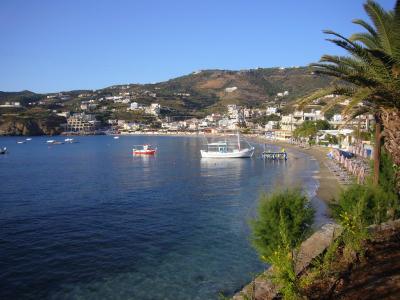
[300, 0, 400, 184]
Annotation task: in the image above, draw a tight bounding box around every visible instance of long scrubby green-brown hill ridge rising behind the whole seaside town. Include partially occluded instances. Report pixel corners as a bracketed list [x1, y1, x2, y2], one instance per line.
[0, 67, 332, 117]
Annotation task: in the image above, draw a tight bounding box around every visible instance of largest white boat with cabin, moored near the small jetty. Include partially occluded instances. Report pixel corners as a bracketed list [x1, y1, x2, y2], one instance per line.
[200, 134, 254, 158]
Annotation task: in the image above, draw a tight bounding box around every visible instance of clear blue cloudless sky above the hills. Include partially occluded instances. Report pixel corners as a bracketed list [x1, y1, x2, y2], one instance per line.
[0, 0, 395, 93]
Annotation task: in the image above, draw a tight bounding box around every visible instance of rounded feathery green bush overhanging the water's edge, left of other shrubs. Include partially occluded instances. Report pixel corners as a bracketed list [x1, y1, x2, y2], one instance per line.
[252, 189, 314, 261]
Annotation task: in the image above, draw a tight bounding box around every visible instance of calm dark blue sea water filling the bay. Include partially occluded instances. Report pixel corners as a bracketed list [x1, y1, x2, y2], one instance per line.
[0, 136, 318, 300]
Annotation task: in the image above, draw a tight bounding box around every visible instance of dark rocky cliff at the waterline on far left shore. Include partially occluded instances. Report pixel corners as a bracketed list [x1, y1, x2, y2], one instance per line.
[0, 116, 66, 135]
